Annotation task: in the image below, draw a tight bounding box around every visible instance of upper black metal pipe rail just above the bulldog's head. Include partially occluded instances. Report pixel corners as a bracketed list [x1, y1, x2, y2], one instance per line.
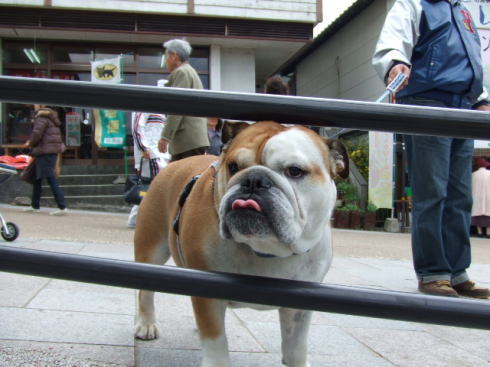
[0, 76, 490, 140]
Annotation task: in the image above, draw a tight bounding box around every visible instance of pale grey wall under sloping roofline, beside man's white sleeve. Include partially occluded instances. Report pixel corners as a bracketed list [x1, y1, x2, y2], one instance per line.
[296, 1, 386, 101]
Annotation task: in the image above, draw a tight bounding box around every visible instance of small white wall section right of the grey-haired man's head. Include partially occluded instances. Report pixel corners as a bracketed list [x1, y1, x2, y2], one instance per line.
[221, 48, 255, 93]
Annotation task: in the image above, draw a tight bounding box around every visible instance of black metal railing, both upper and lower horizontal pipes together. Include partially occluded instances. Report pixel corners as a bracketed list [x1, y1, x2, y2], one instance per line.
[0, 77, 490, 329]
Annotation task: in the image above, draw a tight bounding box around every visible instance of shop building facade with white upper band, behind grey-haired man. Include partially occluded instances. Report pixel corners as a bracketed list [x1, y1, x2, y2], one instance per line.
[0, 0, 322, 155]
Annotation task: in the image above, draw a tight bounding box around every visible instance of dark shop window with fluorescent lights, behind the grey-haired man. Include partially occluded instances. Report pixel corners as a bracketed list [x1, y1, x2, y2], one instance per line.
[0, 41, 209, 150]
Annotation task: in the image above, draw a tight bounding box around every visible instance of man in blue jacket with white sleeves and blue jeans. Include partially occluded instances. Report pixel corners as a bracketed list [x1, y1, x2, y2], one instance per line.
[373, 0, 490, 298]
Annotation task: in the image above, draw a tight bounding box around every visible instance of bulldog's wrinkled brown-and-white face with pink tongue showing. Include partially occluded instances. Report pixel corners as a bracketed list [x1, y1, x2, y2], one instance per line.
[216, 122, 347, 257]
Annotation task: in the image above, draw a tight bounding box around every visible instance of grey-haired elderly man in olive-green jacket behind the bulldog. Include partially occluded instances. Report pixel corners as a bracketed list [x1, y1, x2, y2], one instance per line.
[158, 39, 209, 161]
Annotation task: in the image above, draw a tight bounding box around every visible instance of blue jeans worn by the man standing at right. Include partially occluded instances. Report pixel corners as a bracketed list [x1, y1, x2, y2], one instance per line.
[398, 97, 474, 285]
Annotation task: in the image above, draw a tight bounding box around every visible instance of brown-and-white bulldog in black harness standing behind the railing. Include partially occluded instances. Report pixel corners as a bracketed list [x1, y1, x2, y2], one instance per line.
[134, 121, 348, 367]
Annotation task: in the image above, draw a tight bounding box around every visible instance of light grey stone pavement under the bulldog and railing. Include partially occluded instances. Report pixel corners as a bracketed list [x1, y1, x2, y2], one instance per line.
[0, 205, 490, 367]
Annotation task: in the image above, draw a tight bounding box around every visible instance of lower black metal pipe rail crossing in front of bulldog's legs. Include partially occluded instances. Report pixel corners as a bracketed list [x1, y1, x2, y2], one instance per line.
[0, 246, 490, 329]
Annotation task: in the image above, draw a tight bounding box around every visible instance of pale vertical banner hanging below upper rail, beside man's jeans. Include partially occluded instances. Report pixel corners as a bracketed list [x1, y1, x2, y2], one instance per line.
[368, 131, 394, 209]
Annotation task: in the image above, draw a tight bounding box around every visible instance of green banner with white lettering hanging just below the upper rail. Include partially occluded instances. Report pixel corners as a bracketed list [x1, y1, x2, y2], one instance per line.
[93, 109, 126, 148]
